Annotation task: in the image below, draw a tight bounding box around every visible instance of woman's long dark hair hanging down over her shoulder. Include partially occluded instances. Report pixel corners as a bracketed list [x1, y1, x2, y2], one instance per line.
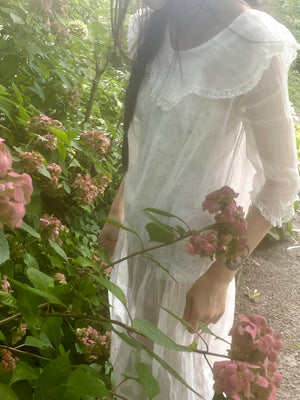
[111, 0, 257, 172]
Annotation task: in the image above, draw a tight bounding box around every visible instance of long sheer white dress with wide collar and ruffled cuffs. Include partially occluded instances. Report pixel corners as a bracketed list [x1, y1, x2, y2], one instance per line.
[110, 9, 299, 400]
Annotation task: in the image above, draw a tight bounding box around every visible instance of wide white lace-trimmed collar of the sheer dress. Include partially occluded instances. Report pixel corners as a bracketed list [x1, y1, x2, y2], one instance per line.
[148, 9, 300, 111]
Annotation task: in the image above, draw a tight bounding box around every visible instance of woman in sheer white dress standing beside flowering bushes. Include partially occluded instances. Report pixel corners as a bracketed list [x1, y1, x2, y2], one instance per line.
[99, 0, 299, 400]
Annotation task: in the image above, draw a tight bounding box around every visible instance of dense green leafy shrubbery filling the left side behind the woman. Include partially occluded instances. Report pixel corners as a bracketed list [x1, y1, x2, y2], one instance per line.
[0, 0, 300, 400]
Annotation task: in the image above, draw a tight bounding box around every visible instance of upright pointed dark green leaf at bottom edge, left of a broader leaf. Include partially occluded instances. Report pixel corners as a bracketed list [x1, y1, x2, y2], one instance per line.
[35, 353, 71, 400]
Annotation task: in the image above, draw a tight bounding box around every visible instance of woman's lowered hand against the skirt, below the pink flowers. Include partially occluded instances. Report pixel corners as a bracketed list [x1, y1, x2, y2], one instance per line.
[183, 261, 234, 333]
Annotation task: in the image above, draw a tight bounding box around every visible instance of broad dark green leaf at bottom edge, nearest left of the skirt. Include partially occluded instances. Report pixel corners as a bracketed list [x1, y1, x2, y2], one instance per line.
[68, 368, 110, 399]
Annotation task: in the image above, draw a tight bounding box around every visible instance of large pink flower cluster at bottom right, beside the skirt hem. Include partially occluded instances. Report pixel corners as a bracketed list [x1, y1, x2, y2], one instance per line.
[213, 315, 282, 400]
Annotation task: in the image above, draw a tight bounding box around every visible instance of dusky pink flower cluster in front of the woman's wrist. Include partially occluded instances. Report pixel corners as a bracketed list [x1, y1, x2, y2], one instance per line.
[185, 186, 247, 263]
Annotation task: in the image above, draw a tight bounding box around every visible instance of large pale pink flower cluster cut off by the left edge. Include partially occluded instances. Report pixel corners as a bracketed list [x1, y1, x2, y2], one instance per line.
[0, 138, 33, 229]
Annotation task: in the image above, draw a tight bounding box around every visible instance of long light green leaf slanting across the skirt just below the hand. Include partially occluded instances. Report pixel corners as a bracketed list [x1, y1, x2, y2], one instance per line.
[132, 318, 190, 352]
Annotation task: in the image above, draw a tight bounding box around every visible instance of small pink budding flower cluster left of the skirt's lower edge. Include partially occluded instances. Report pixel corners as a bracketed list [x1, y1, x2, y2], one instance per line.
[76, 326, 111, 361]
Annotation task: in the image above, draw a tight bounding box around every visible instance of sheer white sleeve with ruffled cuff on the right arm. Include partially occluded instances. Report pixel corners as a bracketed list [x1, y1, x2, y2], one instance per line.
[242, 56, 300, 226]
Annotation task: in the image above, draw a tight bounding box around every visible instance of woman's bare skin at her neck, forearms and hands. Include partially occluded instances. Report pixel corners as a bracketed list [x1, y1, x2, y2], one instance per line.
[98, 0, 271, 333]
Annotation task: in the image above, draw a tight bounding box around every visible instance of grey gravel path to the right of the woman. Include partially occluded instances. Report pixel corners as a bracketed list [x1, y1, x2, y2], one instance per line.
[236, 210, 300, 400]
